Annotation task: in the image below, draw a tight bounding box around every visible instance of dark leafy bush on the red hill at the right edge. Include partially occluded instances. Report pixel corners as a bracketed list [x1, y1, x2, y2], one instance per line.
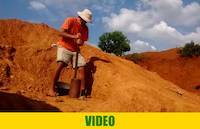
[178, 41, 200, 57]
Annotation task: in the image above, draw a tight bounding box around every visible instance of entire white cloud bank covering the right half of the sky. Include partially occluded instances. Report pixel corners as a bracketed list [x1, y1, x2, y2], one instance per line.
[102, 0, 200, 51]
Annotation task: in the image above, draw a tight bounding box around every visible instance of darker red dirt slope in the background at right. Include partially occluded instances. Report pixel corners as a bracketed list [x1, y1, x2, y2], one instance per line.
[139, 49, 200, 94]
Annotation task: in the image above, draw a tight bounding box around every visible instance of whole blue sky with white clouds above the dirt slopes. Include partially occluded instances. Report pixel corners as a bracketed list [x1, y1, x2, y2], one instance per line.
[0, 0, 200, 52]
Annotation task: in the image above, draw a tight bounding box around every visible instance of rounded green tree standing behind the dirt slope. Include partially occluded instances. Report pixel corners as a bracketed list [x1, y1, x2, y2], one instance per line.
[98, 31, 130, 56]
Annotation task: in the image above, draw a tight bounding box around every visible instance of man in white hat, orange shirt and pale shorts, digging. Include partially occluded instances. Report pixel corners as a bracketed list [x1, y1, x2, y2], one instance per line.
[49, 9, 92, 96]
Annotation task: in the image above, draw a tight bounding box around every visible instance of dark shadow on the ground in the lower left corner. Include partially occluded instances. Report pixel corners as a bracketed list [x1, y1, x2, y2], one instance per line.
[0, 92, 60, 112]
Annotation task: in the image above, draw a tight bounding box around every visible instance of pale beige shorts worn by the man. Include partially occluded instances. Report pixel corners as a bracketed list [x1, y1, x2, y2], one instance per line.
[57, 46, 86, 68]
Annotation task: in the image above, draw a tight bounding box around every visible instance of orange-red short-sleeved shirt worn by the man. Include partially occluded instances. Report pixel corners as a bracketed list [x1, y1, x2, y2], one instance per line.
[58, 17, 88, 52]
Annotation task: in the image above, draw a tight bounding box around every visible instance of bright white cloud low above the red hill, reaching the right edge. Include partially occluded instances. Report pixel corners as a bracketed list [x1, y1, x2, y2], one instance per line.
[144, 21, 200, 48]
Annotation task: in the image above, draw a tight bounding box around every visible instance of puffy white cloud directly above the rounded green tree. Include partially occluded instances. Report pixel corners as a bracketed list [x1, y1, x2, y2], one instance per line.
[103, 8, 157, 32]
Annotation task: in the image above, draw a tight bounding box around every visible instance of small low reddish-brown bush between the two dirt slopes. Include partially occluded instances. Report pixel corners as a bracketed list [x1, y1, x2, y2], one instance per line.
[125, 53, 144, 64]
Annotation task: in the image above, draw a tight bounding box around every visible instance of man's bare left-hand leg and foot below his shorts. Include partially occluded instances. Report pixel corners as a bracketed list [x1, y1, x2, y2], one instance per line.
[49, 62, 65, 97]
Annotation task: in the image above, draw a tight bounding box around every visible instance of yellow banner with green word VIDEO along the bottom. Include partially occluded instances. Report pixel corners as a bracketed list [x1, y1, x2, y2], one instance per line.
[0, 113, 200, 129]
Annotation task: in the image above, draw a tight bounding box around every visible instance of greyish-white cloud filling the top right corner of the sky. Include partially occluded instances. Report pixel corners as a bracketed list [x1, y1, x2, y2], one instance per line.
[141, 0, 200, 27]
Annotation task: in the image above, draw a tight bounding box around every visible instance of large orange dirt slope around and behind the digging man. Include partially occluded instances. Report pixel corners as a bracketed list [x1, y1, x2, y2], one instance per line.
[0, 20, 200, 112]
